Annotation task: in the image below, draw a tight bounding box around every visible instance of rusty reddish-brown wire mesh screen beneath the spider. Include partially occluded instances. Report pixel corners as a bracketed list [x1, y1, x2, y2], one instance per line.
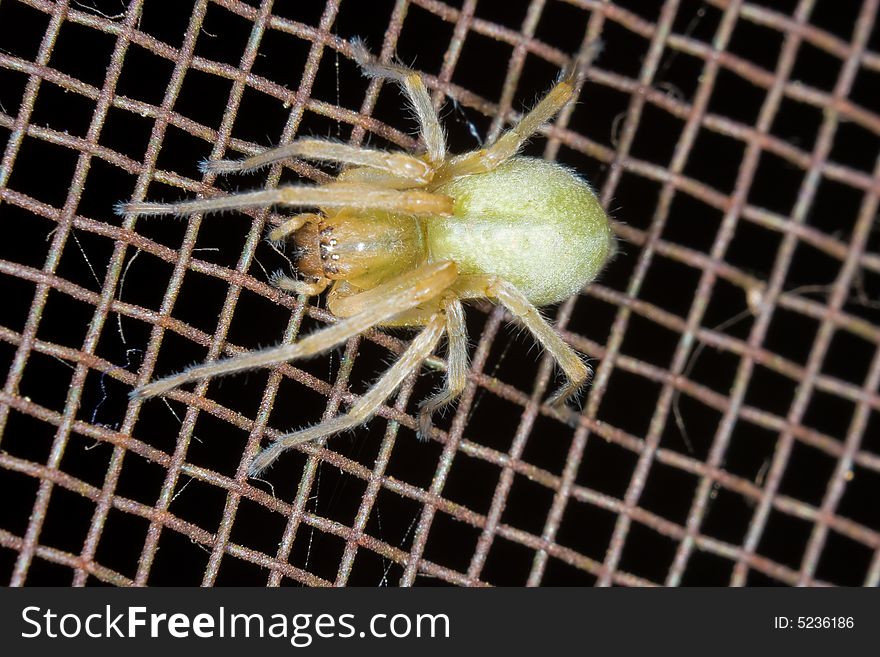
[0, 0, 880, 585]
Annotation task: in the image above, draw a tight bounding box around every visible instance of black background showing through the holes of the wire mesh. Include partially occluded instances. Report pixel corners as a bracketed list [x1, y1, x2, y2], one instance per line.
[0, 0, 880, 586]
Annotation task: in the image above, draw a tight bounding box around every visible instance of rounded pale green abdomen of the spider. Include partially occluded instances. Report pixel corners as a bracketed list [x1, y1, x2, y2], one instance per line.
[423, 157, 614, 306]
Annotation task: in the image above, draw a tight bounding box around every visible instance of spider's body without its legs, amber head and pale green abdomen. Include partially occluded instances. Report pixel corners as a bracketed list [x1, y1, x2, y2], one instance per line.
[294, 156, 613, 325]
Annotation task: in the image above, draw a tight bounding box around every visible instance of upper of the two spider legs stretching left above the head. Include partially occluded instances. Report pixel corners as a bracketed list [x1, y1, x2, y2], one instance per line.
[201, 139, 433, 184]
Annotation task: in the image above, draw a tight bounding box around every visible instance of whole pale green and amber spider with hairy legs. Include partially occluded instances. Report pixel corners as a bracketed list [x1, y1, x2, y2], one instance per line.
[118, 42, 614, 476]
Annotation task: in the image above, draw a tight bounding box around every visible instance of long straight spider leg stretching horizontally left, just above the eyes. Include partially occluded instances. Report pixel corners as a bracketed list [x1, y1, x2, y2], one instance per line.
[116, 183, 452, 216]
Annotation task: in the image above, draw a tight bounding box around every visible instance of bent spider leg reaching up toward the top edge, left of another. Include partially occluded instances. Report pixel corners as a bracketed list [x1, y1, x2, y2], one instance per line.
[351, 40, 446, 166]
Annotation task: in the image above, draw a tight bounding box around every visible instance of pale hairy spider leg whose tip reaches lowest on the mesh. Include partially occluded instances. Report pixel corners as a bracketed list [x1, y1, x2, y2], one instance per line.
[249, 315, 444, 477]
